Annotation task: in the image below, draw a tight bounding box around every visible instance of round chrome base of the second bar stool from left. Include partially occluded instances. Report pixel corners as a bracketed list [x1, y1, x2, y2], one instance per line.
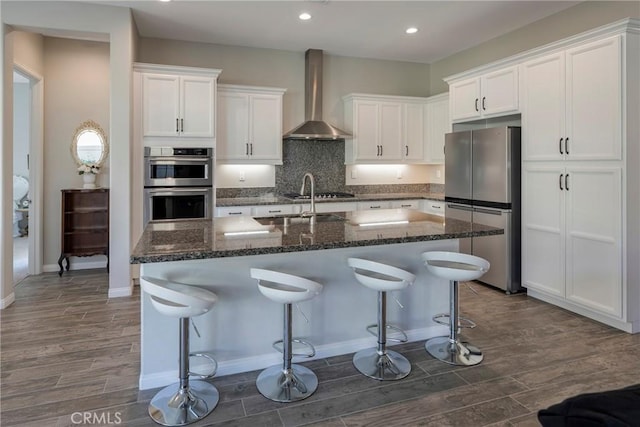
[256, 364, 318, 403]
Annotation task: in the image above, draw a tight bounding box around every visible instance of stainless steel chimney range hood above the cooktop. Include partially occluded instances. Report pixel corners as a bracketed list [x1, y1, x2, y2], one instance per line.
[283, 49, 351, 140]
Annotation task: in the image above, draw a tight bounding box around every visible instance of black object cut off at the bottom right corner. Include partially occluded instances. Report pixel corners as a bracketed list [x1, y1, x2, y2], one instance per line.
[538, 384, 640, 427]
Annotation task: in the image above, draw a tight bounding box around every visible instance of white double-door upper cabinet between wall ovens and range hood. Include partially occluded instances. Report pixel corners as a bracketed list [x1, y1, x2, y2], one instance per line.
[217, 85, 285, 164]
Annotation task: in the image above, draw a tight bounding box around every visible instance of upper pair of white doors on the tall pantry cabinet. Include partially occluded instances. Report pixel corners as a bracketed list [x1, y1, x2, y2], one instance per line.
[522, 36, 622, 160]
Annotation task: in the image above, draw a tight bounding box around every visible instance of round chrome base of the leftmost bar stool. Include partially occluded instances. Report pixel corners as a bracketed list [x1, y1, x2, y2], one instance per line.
[149, 380, 220, 426]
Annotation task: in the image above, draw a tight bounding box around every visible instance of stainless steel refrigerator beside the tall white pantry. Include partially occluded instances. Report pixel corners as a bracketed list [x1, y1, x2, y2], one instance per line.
[445, 126, 522, 293]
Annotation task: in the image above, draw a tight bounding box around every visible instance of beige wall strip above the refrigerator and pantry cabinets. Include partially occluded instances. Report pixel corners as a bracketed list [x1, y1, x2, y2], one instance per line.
[429, 1, 640, 94]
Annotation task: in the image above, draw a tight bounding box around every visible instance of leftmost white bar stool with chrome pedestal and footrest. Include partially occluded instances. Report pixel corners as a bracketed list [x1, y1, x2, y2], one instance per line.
[140, 277, 219, 426]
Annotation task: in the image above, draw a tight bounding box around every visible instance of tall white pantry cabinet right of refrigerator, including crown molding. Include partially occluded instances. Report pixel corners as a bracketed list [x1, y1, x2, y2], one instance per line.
[447, 19, 640, 333]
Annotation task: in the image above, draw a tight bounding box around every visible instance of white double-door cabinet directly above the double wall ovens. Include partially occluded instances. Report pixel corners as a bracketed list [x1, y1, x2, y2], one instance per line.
[142, 73, 216, 138]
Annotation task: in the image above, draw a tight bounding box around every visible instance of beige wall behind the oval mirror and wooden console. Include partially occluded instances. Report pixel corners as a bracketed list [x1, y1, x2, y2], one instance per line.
[44, 37, 110, 266]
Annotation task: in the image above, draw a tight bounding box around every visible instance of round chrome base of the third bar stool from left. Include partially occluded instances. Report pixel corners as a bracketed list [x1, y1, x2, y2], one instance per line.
[353, 348, 411, 381]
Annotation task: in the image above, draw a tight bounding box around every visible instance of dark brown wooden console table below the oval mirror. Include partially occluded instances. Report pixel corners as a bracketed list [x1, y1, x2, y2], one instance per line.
[58, 188, 109, 276]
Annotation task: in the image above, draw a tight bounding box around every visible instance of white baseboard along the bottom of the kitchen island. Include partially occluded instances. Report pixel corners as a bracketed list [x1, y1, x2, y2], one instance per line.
[138, 325, 449, 390]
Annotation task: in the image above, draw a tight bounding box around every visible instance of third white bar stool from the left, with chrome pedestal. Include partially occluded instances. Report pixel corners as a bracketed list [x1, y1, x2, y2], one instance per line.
[347, 258, 416, 381]
